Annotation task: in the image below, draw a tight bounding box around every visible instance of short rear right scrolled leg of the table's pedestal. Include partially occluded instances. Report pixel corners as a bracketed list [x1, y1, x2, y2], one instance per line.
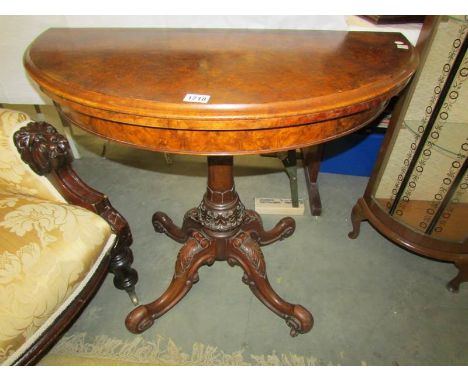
[241, 210, 296, 246]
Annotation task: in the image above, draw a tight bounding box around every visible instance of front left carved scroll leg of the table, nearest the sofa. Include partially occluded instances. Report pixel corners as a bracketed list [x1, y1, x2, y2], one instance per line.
[125, 232, 216, 333]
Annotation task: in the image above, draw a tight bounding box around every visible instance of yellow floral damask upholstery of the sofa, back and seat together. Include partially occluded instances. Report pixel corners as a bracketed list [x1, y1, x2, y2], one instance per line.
[0, 109, 115, 364]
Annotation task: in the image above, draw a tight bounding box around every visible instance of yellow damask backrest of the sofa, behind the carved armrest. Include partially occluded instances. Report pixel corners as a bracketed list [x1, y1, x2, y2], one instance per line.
[0, 109, 64, 202]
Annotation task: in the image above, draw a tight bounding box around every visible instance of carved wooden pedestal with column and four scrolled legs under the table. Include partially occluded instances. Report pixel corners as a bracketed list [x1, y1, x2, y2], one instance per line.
[126, 157, 313, 336]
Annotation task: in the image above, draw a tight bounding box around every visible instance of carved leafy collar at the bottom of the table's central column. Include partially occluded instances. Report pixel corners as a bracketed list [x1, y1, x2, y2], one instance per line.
[197, 199, 245, 232]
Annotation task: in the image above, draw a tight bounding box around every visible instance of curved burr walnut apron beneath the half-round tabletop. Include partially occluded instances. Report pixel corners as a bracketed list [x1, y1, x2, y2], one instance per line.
[54, 100, 388, 155]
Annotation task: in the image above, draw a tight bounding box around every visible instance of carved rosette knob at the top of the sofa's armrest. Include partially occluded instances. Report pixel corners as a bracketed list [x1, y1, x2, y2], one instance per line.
[13, 122, 72, 175]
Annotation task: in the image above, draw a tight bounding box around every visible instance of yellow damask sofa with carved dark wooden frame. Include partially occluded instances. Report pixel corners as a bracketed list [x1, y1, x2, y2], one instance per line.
[0, 109, 138, 365]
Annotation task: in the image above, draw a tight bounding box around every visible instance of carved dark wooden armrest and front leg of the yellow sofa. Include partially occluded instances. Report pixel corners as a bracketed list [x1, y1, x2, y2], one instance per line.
[13, 122, 138, 305]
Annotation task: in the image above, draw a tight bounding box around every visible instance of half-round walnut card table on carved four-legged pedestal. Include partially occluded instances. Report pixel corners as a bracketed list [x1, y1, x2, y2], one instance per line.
[24, 29, 418, 336]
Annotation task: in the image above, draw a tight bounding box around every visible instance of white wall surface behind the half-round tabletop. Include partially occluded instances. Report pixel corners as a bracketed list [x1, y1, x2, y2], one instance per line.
[0, 15, 420, 104]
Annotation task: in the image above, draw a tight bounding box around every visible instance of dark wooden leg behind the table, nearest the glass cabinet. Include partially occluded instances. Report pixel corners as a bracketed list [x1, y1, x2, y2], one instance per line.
[302, 145, 323, 216]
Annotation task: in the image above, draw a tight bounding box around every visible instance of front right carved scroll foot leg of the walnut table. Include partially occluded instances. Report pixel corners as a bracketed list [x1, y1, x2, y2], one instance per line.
[227, 231, 314, 337]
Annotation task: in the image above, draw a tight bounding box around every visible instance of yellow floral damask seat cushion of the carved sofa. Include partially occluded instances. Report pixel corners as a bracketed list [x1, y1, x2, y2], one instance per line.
[0, 192, 113, 363]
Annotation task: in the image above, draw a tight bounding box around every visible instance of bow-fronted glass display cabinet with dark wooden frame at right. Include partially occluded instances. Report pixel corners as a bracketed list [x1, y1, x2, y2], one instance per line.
[348, 16, 468, 292]
